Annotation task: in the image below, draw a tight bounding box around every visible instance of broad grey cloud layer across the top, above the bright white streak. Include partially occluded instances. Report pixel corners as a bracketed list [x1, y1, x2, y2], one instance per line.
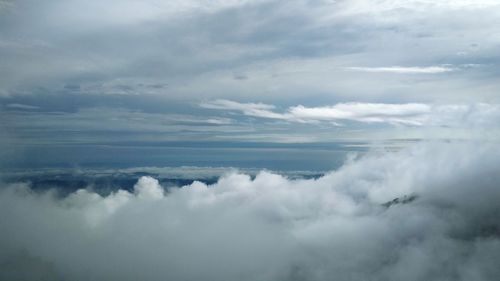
[0, 0, 499, 101]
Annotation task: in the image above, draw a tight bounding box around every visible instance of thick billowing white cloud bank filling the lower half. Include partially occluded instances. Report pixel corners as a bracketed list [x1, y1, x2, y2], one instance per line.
[0, 142, 500, 281]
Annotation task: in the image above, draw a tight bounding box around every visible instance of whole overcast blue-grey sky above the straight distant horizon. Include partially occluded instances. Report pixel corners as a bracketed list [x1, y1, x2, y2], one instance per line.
[0, 0, 500, 148]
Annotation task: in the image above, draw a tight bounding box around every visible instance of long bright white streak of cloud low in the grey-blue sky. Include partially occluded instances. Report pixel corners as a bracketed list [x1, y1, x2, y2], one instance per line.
[200, 100, 500, 127]
